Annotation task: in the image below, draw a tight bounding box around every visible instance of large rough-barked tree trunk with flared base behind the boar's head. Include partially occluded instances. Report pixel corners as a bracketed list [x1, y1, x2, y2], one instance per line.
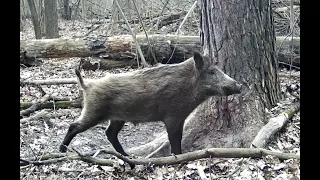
[182, 0, 280, 150]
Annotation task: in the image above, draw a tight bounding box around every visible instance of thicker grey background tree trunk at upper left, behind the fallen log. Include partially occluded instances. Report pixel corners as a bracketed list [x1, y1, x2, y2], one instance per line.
[44, 0, 59, 39]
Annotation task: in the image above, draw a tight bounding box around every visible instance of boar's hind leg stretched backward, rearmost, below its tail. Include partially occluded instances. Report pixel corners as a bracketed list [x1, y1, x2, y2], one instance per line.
[60, 116, 101, 152]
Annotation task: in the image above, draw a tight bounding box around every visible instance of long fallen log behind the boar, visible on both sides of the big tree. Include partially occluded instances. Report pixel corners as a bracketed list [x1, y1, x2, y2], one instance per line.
[20, 34, 300, 67]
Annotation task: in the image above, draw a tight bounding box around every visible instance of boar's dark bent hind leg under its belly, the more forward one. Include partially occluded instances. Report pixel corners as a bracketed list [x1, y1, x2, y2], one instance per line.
[106, 121, 128, 156]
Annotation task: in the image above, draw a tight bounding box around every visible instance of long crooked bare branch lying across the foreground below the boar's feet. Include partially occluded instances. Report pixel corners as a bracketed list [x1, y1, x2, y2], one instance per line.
[20, 148, 300, 166]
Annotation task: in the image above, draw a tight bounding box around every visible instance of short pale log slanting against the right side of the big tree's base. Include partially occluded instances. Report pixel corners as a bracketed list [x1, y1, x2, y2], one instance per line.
[251, 103, 300, 148]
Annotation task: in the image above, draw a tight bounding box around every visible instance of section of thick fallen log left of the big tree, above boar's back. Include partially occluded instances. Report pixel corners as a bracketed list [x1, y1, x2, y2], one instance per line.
[20, 35, 192, 62]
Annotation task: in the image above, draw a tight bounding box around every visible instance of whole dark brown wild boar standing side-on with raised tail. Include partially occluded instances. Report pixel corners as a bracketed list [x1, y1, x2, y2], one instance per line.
[60, 52, 241, 161]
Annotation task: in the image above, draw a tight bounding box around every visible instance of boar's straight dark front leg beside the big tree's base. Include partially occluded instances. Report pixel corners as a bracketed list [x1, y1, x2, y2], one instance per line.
[165, 119, 183, 154]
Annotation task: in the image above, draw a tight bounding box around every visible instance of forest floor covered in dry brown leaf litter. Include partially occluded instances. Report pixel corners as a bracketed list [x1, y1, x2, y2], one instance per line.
[20, 21, 300, 180]
